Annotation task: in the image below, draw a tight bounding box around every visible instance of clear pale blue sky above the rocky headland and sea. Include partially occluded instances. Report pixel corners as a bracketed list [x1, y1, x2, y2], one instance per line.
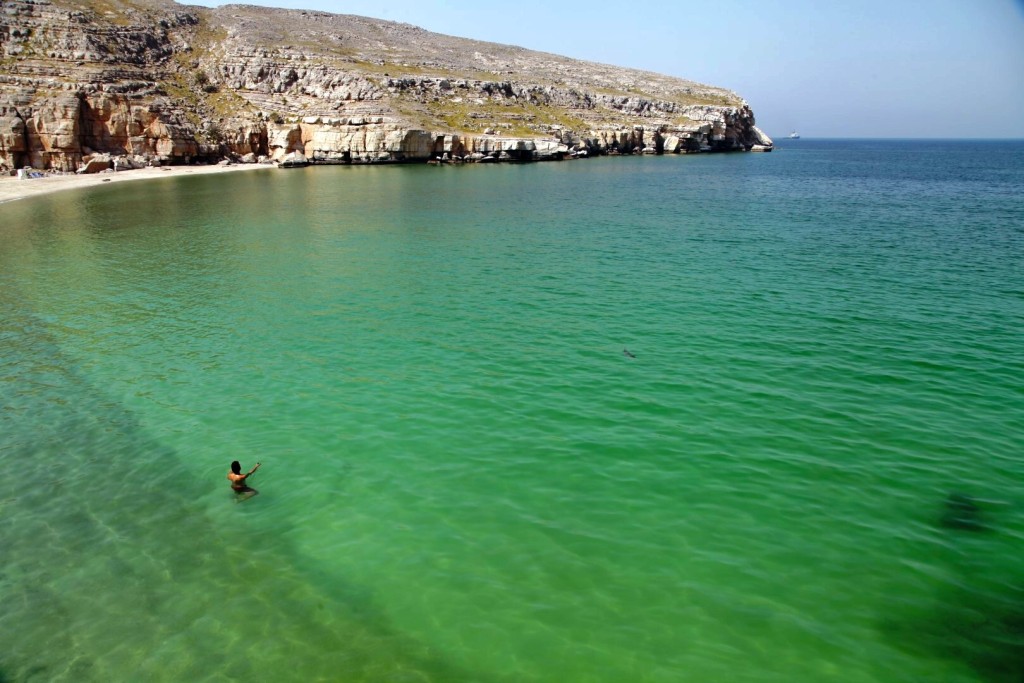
[188, 0, 1024, 138]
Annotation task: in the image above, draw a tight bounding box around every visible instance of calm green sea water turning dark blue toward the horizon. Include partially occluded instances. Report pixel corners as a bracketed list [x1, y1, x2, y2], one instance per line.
[0, 140, 1024, 683]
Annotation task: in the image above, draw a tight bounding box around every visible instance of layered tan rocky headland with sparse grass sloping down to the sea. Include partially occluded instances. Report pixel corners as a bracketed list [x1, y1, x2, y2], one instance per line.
[0, 0, 771, 171]
